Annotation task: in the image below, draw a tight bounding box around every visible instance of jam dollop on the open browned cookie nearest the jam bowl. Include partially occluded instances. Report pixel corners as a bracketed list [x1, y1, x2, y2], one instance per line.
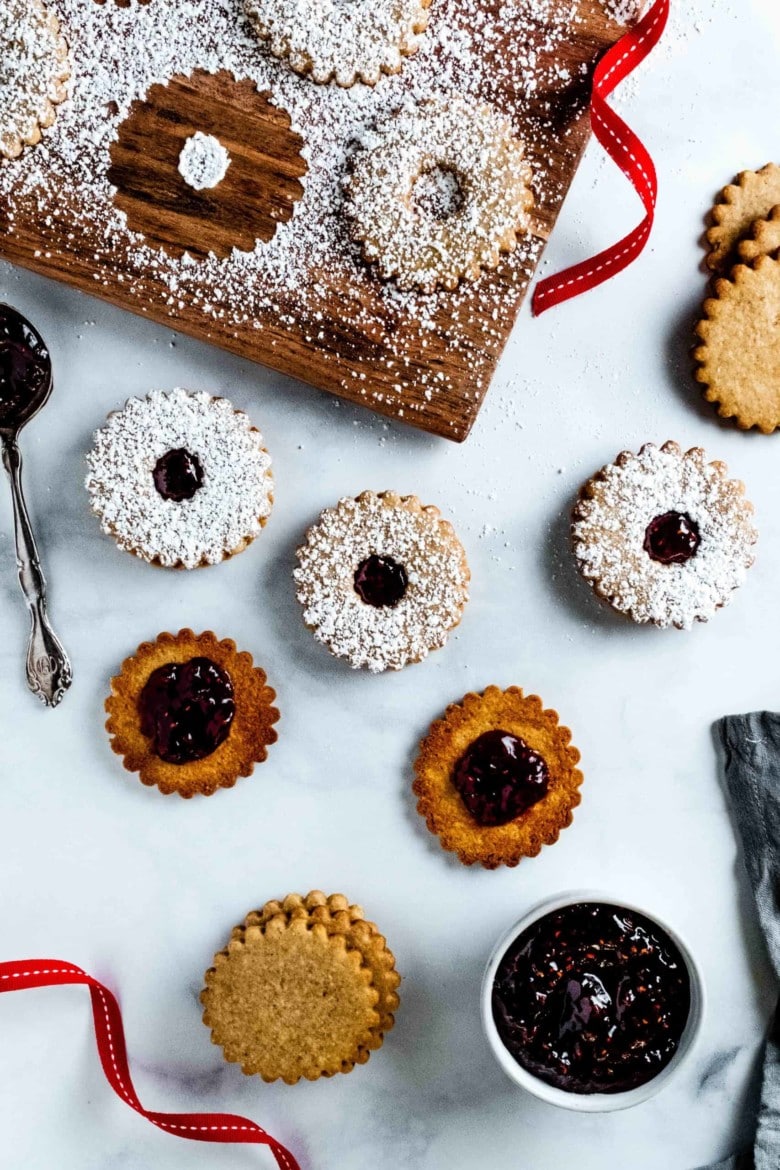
[453, 731, 550, 827]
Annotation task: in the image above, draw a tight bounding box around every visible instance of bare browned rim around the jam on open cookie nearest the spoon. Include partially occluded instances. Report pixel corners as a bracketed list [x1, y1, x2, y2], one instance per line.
[105, 629, 279, 799]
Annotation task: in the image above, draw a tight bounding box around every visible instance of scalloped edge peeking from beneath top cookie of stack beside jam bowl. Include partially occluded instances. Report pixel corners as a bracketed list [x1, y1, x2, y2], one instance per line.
[233, 889, 401, 1064]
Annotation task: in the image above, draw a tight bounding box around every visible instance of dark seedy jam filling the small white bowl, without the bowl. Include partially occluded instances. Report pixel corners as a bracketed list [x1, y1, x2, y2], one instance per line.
[492, 902, 691, 1093]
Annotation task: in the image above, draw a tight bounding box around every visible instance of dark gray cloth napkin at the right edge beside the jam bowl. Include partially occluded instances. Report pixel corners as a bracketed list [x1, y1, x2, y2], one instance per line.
[702, 711, 780, 1170]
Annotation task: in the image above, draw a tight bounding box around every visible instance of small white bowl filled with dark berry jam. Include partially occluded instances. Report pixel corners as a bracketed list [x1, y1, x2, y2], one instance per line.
[482, 892, 705, 1113]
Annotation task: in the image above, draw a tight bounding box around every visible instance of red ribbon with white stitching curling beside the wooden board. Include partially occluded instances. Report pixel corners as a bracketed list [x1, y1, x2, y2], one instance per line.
[532, 0, 669, 317]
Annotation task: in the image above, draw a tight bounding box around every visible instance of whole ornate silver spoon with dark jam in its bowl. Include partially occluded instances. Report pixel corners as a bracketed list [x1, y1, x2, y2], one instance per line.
[0, 304, 73, 707]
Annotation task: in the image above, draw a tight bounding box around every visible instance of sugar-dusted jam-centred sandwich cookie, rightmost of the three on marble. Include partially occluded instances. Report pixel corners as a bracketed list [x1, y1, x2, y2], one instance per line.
[572, 442, 758, 629]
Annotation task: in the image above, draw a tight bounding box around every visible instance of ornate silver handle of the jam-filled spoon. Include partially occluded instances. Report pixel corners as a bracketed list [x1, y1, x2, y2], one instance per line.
[2, 439, 73, 707]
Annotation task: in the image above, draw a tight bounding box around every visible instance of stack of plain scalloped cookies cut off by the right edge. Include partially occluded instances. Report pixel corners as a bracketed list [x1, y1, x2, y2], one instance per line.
[693, 163, 780, 434]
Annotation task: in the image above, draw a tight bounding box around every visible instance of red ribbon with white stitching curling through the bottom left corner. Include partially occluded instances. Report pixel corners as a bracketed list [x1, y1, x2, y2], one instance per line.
[0, 958, 301, 1170]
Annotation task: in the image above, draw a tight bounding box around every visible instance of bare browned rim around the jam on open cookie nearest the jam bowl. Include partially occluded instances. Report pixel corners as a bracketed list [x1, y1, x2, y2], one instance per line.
[412, 687, 582, 869]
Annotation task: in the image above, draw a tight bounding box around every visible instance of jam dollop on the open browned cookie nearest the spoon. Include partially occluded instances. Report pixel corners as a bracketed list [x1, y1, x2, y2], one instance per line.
[138, 658, 235, 764]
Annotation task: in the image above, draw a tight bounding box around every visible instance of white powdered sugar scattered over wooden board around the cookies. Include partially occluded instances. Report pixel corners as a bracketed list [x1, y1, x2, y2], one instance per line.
[0, 0, 622, 430]
